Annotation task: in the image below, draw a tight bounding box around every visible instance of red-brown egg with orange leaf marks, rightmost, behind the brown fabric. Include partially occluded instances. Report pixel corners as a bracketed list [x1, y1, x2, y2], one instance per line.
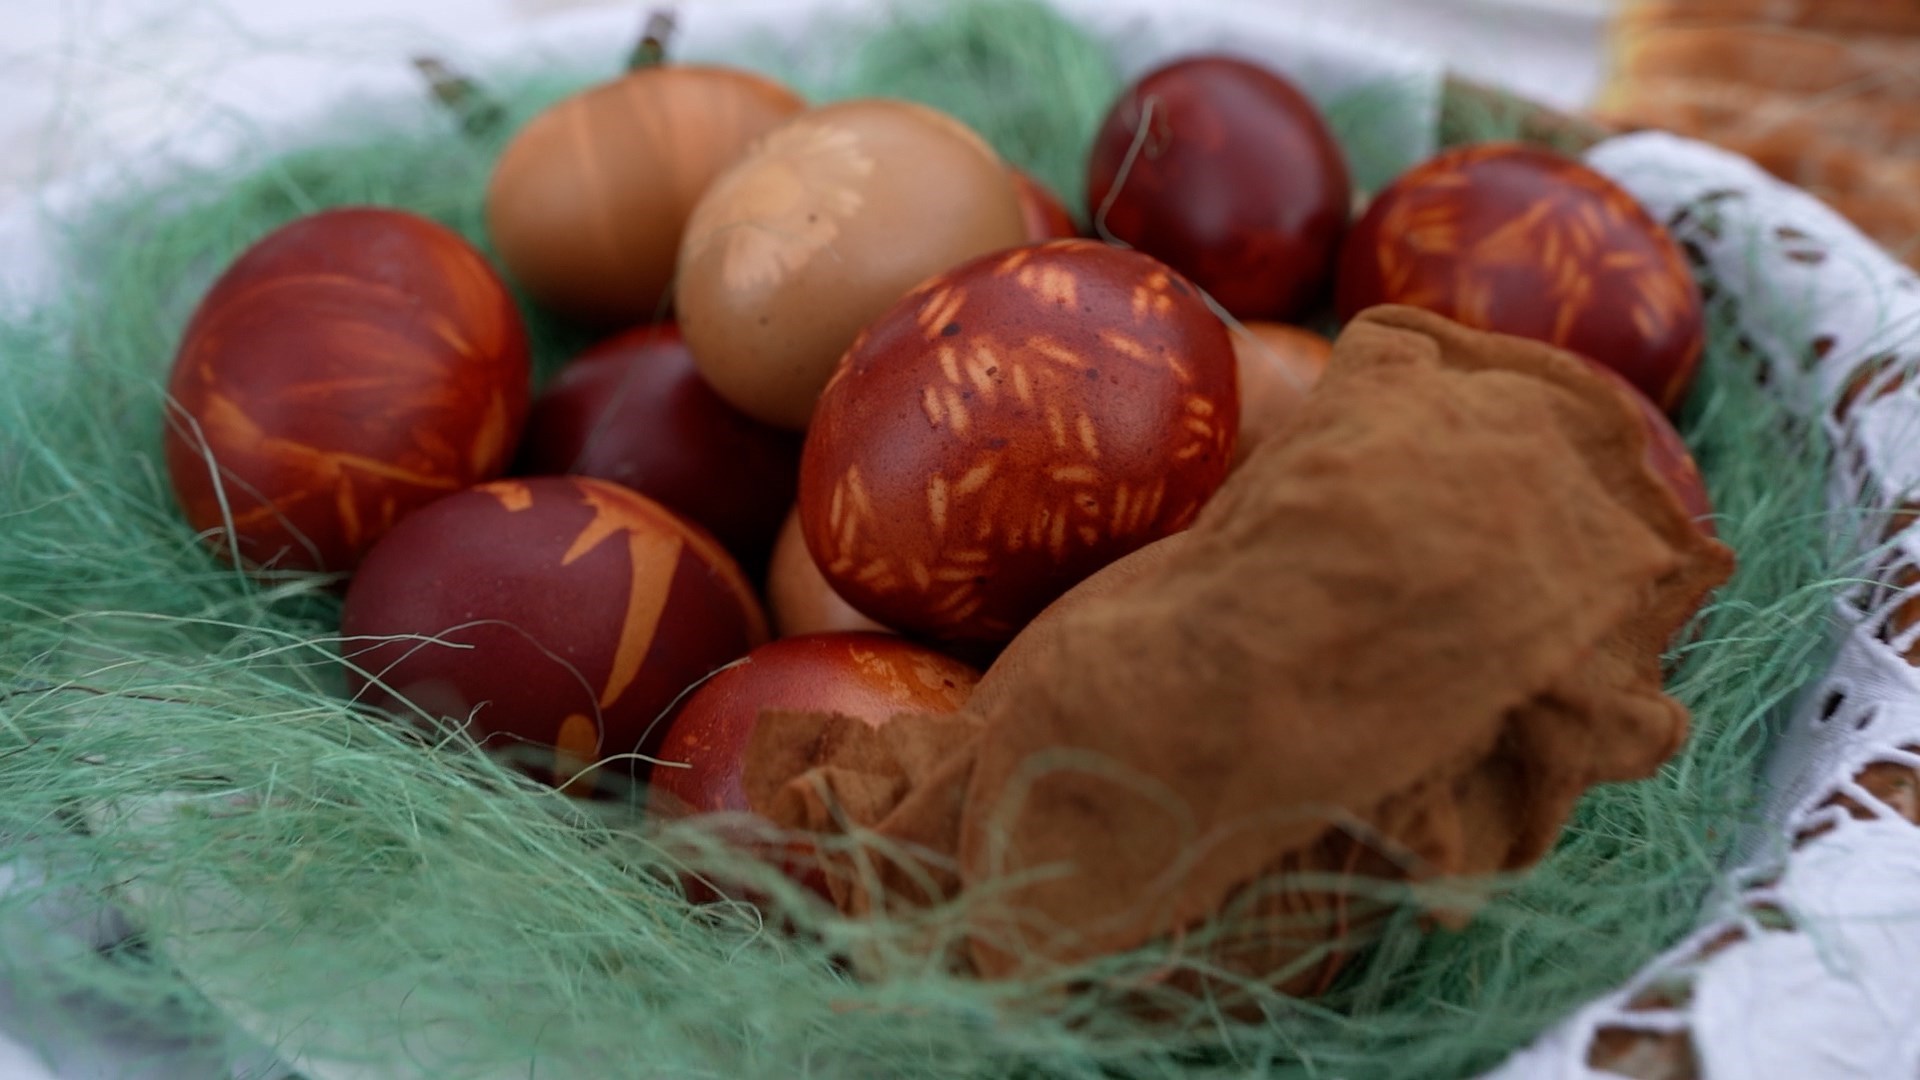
[1336, 142, 1705, 411]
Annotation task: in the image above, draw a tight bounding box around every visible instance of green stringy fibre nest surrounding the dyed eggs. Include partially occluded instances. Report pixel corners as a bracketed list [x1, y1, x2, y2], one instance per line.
[0, 0, 1845, 1078]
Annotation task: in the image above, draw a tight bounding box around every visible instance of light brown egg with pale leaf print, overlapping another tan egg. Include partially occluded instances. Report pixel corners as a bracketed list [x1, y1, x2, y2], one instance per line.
[674, 100, 1027, 430]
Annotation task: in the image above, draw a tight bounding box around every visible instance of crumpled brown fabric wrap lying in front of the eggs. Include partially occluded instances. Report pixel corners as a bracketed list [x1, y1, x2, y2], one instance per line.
[747, 307, 1734, 994]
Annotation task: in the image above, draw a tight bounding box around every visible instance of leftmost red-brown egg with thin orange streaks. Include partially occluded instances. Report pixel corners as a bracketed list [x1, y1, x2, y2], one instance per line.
[165, 208, 530, 571]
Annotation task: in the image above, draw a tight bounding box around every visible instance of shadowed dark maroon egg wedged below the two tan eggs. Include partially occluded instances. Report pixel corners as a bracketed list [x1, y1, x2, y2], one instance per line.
[516, 323, 801, 569]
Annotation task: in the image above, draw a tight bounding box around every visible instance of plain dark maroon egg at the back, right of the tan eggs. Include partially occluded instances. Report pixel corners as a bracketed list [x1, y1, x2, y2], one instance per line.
[1087, 56, 1354, 319]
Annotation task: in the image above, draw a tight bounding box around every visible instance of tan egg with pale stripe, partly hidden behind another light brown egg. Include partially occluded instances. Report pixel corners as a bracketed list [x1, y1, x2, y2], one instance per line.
[486, 65, 804, 323]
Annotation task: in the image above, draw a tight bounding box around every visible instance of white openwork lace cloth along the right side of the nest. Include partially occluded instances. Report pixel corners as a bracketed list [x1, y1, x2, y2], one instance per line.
[1492, 135, 1920, 1080]
